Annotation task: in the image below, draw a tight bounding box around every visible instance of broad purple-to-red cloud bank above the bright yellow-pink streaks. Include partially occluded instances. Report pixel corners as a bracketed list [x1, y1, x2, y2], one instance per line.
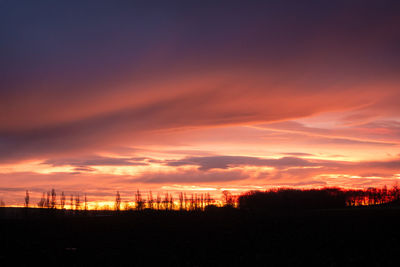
[0, 1, 399, 161]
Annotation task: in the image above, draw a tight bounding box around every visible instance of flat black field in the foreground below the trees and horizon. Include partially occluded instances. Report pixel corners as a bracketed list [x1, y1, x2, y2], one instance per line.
[0, 208, 400, 266]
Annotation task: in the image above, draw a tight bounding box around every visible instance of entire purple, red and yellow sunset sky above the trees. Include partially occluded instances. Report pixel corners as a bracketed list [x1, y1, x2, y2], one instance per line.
[0, 0, 400, 205]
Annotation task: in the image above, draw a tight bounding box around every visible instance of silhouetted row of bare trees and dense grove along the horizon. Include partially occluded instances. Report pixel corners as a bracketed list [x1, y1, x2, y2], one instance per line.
[18, 184, 400, 211]
